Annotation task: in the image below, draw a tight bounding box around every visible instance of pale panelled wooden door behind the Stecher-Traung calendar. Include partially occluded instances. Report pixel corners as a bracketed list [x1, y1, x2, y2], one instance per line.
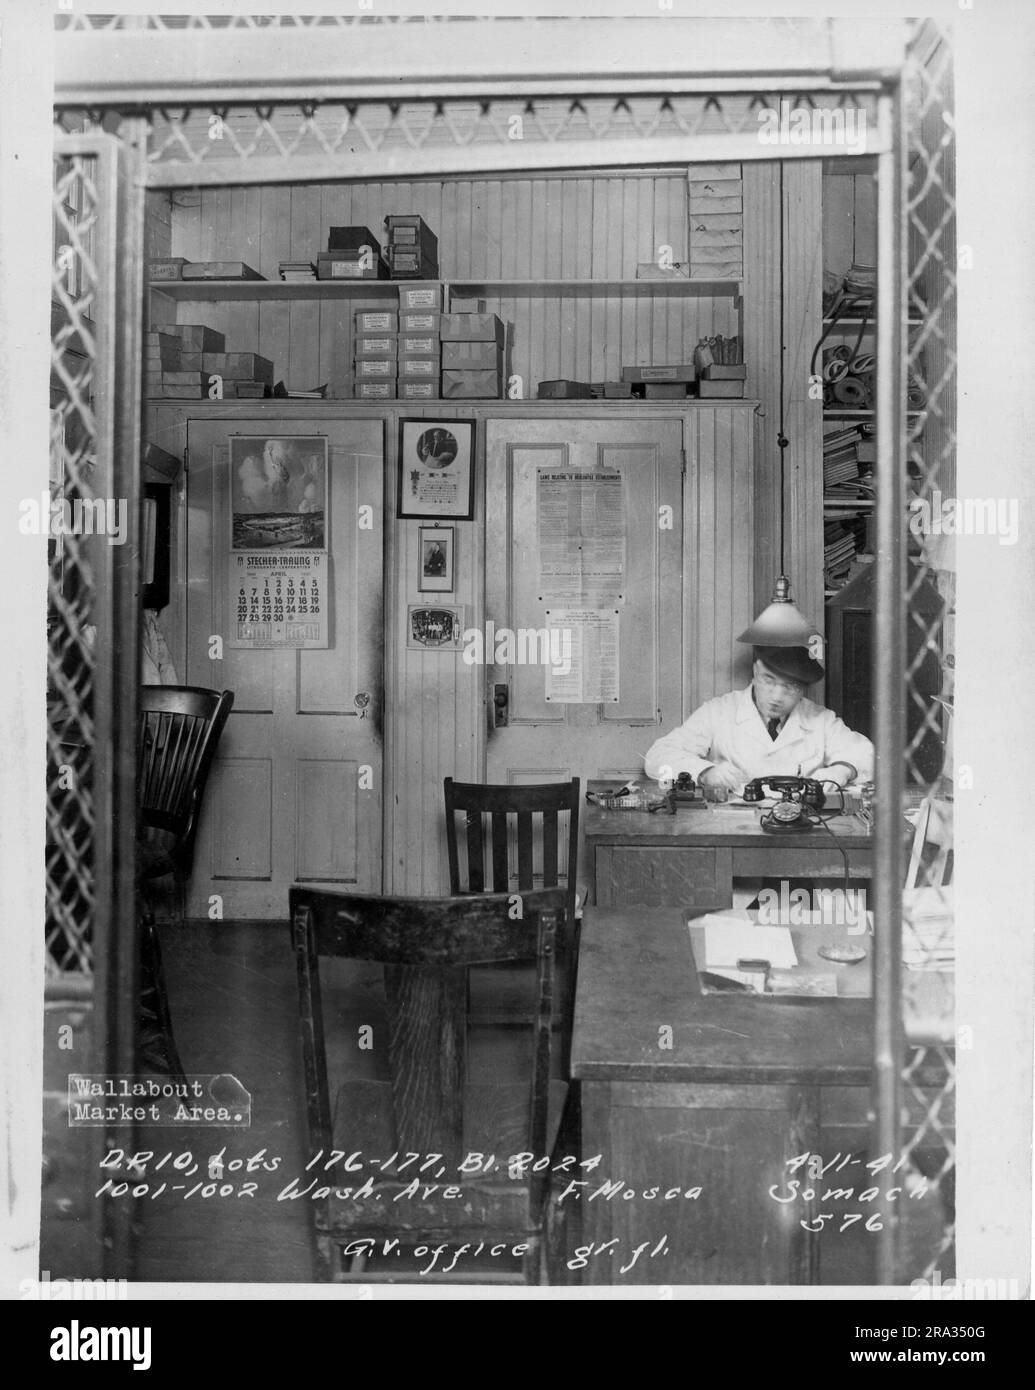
[186, 416, 383, 920]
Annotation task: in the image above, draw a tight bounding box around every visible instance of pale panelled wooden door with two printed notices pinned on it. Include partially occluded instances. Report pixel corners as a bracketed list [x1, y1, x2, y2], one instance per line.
[485, 417, 684, 783]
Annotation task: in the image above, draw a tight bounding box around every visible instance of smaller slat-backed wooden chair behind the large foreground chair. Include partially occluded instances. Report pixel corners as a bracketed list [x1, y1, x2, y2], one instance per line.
[445, 777, 585, 1074]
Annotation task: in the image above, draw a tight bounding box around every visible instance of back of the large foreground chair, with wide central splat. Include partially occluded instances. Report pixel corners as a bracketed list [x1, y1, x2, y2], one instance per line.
[289, 887, 565, 1163]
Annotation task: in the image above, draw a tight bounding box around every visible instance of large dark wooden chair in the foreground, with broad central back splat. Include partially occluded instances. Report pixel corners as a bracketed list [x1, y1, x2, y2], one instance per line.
[289, 887, 567, 1283]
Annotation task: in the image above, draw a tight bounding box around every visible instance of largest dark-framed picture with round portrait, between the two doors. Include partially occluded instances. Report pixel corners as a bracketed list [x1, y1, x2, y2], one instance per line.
[397, 420, 475, 521]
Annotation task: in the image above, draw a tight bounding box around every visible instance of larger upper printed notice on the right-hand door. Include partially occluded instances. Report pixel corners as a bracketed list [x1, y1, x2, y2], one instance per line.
[536, 468, 625, 609]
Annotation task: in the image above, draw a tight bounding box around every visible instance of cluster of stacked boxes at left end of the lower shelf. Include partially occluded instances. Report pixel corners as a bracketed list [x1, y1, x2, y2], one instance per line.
[146, 324, 274, 400]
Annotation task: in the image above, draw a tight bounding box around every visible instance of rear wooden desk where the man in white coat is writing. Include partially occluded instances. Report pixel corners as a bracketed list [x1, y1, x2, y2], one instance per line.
[583, 783, 872, 908]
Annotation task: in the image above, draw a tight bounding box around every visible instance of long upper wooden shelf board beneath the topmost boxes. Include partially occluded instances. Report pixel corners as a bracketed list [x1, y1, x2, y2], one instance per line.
[150, 279, 742, 300]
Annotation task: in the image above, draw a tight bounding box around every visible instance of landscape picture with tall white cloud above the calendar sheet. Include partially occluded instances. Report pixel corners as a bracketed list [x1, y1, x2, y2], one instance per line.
[231, 435, 328, 550]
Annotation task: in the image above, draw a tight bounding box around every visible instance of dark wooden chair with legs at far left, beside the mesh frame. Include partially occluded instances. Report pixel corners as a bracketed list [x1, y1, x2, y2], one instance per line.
[136, 685, 233, 1079]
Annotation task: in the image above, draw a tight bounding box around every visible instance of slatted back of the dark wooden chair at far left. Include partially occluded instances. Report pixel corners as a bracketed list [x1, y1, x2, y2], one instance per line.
[136, 685, 233, 874]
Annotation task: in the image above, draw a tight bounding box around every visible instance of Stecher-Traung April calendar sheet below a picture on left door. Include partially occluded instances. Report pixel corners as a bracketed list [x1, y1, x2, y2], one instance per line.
[226, 550, 329, 648]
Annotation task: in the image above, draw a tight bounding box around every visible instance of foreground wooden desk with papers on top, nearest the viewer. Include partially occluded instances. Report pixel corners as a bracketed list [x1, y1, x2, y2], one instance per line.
[558, 906, 879, 1284]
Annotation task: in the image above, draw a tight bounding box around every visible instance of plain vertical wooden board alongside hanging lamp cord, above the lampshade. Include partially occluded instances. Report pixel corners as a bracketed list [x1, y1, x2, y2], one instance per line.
[743, 161, 781, 610]
